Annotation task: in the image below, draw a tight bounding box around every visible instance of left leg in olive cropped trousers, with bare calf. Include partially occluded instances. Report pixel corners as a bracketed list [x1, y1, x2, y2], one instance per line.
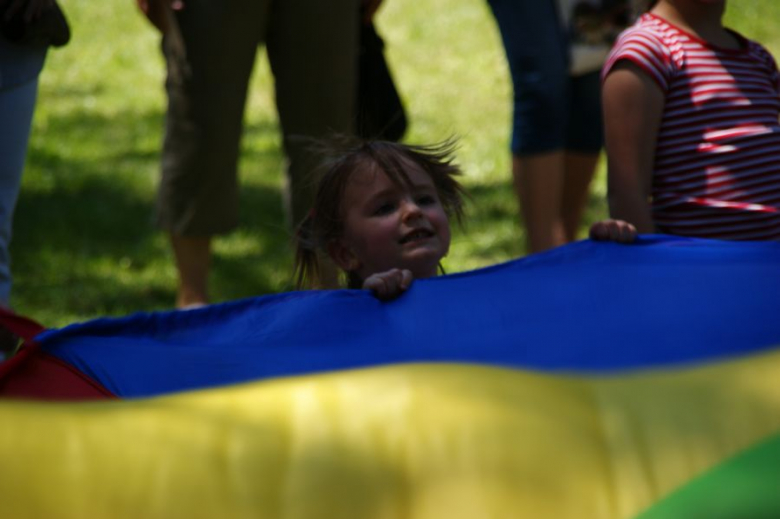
[157, 0, 267, 306]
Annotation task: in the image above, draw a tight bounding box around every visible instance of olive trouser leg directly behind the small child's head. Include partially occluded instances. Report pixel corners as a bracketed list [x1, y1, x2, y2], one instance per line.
[267, 0, 359, 288]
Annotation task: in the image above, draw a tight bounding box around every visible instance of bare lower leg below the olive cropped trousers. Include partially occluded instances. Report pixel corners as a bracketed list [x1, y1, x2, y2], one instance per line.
[170, 234, 211, 308]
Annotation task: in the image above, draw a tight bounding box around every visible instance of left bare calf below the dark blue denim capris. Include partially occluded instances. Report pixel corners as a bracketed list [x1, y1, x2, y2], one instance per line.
[512, 151, 566, 253]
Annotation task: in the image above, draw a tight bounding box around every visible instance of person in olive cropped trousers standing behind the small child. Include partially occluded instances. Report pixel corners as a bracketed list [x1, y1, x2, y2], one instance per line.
[137, 0, 381, 307]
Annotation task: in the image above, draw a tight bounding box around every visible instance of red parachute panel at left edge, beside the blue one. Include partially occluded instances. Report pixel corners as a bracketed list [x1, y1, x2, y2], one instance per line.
[0, 308, 115, 400]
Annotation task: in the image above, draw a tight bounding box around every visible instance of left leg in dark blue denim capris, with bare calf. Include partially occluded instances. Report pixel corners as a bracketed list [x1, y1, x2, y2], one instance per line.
[490, 0, 568, 252]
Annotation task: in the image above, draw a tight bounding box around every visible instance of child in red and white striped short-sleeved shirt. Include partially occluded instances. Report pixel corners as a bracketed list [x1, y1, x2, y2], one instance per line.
[597, 0, 780, 240]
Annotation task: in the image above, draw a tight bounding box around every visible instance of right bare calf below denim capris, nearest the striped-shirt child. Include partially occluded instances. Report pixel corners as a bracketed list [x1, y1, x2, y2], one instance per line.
[561, 152, 599, 241]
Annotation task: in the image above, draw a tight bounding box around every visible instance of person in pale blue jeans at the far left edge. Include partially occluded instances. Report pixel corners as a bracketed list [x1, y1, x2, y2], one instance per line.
[0, 0, 70, 308]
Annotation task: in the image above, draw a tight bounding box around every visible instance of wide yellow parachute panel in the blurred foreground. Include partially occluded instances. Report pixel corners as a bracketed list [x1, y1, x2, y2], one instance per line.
[0, 351, 780, 519]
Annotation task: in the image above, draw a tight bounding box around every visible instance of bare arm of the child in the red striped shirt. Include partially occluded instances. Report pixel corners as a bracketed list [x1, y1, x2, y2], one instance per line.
[602, 60, 664, 233]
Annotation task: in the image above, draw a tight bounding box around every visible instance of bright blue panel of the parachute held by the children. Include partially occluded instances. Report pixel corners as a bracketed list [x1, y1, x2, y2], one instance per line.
[39, 236, 780, 397]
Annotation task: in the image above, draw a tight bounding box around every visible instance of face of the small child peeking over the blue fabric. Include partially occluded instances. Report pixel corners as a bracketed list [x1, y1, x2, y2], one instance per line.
[329, 164, 450, 279]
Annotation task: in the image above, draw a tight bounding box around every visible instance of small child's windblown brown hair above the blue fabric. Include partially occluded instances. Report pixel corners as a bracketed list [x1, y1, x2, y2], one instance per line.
[295, 137, 465, 288]
